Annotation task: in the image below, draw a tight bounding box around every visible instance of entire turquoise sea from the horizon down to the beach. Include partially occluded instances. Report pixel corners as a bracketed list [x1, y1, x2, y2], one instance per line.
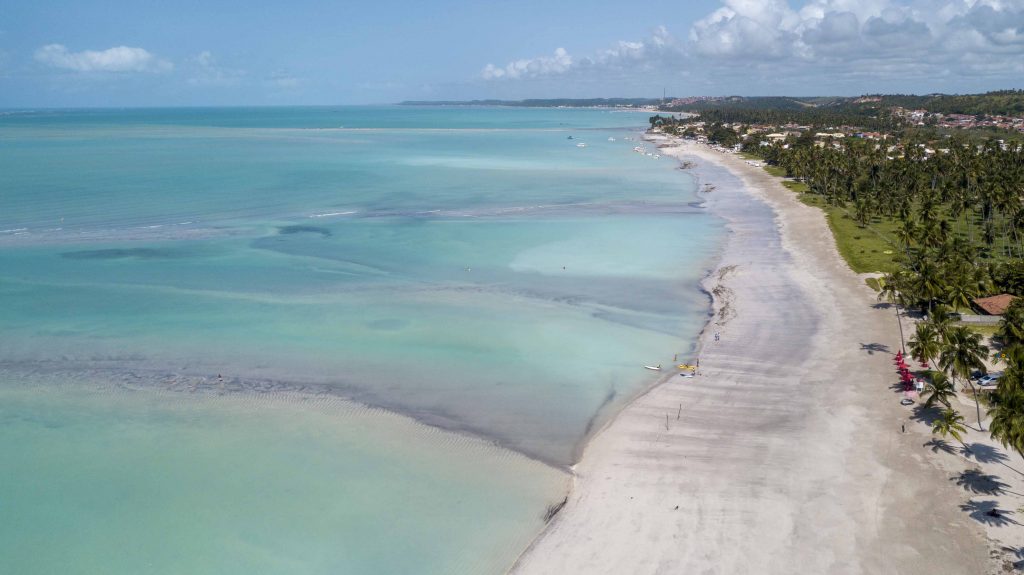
[0, 106, 722, 574]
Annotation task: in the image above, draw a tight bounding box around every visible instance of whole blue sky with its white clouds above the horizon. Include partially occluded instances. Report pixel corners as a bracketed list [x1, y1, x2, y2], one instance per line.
[0, 0, 1024, 107]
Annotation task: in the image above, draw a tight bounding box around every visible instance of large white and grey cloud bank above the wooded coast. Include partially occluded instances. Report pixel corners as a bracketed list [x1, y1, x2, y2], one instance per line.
[480, 0, 1024, 92]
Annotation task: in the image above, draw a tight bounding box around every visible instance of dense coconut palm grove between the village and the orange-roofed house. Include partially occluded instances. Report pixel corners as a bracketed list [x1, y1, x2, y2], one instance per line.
[770, 133, 1024, 310]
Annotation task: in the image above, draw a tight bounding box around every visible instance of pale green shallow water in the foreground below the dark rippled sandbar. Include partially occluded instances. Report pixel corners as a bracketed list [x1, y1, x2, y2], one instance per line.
[0, 382, 565, 575]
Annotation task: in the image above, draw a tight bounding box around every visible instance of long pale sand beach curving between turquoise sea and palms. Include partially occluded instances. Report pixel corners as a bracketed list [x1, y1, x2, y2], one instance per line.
[512, 136, 1009, 574]
